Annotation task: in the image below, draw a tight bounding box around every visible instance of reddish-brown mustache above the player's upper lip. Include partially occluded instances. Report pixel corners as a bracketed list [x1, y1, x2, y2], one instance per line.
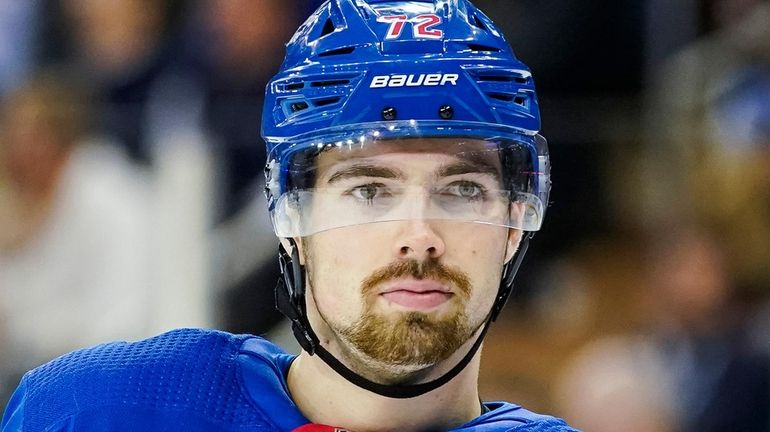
[361, 259, 471, 298]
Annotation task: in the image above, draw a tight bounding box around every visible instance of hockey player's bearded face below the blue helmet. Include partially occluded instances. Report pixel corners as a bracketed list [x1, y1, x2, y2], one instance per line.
[294, 139, 520, 378]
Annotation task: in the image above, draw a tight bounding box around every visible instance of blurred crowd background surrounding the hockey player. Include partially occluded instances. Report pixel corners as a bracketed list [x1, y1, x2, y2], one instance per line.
[0, 0, 770, 432]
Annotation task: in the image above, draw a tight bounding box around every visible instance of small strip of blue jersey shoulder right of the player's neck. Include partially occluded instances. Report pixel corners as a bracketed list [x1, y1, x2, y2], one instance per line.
[458, 402, 579, 432]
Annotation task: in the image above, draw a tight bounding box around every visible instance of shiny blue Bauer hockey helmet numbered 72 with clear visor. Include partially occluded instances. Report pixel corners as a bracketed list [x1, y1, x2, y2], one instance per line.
[262, 0, 550, 237]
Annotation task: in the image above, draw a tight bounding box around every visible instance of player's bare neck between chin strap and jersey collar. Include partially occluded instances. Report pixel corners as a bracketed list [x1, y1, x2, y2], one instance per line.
[288, 338, 481, 432]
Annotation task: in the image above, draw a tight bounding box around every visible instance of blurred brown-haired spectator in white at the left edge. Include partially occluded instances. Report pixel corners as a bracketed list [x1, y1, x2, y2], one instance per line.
[0, 75, 157, 403]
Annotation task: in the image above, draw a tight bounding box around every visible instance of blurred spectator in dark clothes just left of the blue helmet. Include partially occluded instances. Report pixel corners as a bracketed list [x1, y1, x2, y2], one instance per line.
[186, 0, 302, 220]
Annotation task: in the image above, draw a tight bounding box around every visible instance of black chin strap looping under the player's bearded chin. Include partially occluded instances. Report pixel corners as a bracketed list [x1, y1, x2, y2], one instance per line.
[275, 233, 532, 399]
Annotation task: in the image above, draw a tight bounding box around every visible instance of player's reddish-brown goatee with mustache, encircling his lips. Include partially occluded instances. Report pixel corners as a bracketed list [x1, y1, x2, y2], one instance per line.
[337, 260, 478, 365]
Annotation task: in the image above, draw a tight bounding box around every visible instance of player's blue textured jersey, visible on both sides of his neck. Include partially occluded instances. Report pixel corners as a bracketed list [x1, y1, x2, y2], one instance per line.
[2, 329, 574, 432]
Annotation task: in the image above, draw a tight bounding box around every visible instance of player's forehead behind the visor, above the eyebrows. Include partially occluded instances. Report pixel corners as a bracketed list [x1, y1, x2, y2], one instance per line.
[315, 138, 500, 176]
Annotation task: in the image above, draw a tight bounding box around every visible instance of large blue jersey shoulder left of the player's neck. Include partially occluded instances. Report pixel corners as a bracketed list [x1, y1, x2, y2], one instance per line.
[8, 329, 284, 430]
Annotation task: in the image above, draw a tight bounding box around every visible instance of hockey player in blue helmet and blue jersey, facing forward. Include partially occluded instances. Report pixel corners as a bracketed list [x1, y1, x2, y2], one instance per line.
[2, 0, 574, 432]
